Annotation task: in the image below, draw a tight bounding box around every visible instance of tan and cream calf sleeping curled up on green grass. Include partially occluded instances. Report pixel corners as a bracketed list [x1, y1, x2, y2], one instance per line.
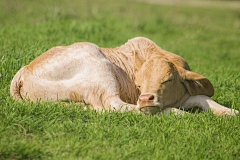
[10, 37, 239, 116]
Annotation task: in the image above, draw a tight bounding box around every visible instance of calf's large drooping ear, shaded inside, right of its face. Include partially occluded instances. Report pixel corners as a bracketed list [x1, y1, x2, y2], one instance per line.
[179, 68, 214, 97]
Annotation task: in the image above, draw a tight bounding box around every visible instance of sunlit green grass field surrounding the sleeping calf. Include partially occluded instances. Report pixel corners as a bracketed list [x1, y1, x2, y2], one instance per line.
[0, 0, 240, 160]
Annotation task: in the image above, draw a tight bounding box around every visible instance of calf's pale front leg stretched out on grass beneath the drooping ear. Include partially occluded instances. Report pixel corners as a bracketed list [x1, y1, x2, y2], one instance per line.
[181, 95, 239, 116]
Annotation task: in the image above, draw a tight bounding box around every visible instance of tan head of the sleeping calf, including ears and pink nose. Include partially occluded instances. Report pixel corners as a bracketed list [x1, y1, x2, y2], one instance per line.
[135, 56, 214, 114]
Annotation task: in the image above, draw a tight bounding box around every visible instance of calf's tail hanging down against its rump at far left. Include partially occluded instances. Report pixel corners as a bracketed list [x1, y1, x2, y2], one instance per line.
[10, 68, 23, 101]
